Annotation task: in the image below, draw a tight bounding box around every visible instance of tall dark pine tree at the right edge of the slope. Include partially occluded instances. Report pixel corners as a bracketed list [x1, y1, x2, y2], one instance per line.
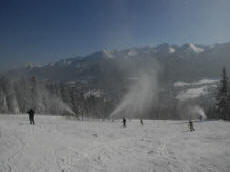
[216, 67, 229, 120]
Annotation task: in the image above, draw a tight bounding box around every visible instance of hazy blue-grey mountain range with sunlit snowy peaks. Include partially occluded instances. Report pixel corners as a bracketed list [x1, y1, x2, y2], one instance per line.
[7, 43, 230, 81]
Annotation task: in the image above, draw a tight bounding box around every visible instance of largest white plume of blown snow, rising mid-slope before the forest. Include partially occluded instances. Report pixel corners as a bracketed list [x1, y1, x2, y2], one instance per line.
[110, 60, 159, 118]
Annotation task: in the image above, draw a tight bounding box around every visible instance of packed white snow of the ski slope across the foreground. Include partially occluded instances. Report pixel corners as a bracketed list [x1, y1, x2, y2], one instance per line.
[0, 115, 230, 172]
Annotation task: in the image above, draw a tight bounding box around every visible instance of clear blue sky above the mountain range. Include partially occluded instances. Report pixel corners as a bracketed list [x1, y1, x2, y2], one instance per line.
[0, 0, 230, 68]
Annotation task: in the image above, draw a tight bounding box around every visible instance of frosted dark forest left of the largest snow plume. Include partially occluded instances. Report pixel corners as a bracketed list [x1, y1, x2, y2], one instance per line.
[0, 77, 113, 118]
